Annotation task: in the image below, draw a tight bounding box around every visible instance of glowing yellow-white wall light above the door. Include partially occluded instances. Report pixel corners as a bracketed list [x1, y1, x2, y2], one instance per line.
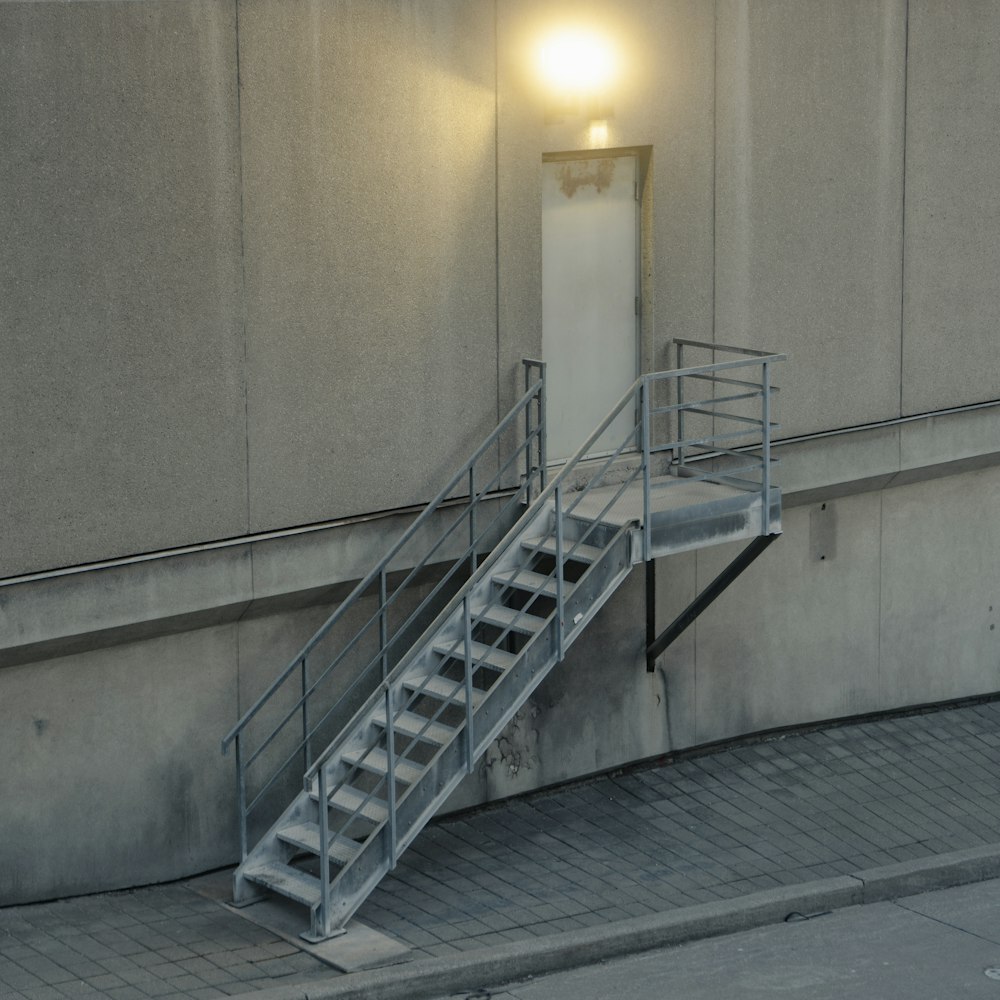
[537, 27, 618, 124]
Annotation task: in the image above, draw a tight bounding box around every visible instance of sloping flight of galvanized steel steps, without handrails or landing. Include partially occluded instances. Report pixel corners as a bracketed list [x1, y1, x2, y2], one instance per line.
[235, 502, 633, 940]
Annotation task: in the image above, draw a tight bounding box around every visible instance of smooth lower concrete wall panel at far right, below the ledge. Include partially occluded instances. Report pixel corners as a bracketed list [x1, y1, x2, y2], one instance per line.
[881, 469, 1000, 707]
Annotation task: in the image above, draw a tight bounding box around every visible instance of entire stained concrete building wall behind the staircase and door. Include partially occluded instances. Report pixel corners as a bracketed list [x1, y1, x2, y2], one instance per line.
[0, 0, 1000, 902]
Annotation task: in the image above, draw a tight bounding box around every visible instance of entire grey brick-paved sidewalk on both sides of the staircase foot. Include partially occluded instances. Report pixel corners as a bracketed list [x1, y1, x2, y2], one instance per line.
[0, 701, 1000, 1000]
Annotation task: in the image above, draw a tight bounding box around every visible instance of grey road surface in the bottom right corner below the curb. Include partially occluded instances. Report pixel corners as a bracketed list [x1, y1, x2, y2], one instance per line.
[442, 880, 1000, 1000]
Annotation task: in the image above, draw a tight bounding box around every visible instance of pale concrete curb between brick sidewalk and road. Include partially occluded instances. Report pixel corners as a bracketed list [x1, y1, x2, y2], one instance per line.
[235, 844, 1000, 1000]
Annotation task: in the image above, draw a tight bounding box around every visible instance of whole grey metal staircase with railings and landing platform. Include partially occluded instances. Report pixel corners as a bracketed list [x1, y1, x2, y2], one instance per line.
[223, 341, 781, 940]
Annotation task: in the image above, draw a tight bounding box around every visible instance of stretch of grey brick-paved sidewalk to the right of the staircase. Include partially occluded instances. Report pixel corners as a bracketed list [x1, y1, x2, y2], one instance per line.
[358, 702, 1000, 956]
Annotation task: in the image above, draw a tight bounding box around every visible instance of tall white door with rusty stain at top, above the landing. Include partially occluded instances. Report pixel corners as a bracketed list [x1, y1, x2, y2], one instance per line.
[542, 156, 639, 462]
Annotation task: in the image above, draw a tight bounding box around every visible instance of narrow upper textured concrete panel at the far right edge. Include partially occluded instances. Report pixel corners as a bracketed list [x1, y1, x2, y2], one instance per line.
[903, 0, 1000, 413]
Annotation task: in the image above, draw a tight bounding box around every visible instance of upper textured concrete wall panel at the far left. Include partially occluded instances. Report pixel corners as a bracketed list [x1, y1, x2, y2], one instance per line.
[0, 0, 247, 576]
